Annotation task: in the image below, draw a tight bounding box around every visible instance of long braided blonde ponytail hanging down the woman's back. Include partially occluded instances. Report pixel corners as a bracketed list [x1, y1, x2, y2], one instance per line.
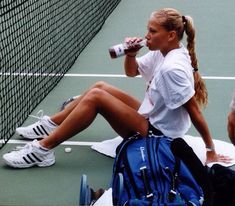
[182, 16, 208, 107]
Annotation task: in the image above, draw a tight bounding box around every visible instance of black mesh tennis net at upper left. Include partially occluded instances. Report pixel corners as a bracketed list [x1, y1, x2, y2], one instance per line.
[0, 0, 121, 148]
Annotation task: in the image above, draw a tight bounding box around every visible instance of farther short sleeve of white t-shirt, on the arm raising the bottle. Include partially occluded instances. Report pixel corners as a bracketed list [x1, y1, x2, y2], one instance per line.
[136, 51, 160, 82]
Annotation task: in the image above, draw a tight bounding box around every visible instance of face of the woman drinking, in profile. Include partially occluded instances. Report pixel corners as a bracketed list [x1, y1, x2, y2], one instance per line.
[145, 18, 170, 51]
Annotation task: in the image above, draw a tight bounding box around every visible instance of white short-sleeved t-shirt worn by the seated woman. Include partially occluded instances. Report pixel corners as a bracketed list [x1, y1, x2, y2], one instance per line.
[137, 44, 195, 138]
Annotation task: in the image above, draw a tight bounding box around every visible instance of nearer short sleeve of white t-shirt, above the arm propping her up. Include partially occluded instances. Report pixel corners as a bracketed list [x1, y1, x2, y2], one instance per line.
[158, 69, 195, 109]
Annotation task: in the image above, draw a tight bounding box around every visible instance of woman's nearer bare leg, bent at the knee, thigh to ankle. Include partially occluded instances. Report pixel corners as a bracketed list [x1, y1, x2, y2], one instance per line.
[40, 88, 148, 149]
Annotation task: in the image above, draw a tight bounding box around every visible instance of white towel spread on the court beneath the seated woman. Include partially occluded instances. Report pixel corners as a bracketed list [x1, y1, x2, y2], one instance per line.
[91, 135, 235, 167]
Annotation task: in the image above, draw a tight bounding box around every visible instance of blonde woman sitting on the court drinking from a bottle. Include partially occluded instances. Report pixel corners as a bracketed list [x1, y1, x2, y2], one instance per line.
[3, 9, 226, 203]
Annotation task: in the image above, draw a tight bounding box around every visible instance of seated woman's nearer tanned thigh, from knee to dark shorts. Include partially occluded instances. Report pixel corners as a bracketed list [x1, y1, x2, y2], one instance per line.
[84, 88, 148, 137]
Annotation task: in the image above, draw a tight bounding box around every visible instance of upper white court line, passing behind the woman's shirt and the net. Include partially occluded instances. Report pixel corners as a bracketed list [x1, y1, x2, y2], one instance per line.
[0, 72, 235, 80]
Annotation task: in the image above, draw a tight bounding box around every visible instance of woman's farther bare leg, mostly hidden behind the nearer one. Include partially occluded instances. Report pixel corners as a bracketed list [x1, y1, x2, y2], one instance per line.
[51, 81, 140, 125]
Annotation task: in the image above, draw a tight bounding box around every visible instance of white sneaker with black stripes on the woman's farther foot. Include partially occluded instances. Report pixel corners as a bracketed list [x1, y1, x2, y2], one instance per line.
[16, 110, 58, 140]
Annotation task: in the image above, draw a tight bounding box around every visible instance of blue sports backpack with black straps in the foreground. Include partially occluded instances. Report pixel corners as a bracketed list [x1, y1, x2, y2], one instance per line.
[112, 135, 203, 206]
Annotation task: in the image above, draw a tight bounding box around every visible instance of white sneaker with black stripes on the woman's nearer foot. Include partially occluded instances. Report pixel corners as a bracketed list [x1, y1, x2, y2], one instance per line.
[3, 140, 55, 168]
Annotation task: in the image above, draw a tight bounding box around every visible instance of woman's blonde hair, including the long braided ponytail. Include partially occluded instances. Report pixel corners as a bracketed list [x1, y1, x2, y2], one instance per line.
[150, 8, 208, 107]
